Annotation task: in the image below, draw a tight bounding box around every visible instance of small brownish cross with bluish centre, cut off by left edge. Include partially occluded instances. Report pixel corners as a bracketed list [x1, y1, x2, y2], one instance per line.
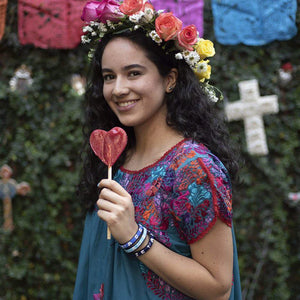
[0, 165, 30, 231]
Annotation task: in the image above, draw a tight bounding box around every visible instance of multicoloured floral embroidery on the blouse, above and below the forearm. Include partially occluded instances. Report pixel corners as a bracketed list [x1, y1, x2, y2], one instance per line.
[115, 140, 232, 300]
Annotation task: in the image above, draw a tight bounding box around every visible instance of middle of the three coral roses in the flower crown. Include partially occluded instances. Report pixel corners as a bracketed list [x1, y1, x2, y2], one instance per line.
[155, 12, 182, 41]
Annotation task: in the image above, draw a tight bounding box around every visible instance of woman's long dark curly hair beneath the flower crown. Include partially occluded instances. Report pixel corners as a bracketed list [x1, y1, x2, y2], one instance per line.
[77, 30, 238, 209]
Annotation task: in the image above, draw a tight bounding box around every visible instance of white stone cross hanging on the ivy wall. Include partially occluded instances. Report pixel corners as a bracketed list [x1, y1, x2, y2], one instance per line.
[225, 79, 278, 155]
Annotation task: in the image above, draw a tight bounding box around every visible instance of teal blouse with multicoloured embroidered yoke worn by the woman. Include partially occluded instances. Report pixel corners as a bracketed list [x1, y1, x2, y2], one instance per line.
[73, 139, 241, 300]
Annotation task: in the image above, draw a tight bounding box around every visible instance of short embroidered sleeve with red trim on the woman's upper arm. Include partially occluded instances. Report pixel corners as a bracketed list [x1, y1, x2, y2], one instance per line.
[170, 150, 232, 244]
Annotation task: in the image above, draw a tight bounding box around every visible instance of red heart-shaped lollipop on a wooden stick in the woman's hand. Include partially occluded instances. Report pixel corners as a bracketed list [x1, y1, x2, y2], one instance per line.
[90, 127, 127, 239]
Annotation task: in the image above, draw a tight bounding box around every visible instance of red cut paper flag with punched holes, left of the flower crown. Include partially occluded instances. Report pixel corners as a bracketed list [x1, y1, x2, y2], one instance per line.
[18, 0, 86, 49]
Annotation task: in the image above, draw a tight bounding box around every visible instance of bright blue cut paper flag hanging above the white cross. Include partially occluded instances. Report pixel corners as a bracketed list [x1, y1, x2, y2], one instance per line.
[212, 0, 297, 46]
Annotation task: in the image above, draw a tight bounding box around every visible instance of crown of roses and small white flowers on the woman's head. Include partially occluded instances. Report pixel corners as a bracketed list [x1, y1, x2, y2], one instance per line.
[81, 0, 222, 102]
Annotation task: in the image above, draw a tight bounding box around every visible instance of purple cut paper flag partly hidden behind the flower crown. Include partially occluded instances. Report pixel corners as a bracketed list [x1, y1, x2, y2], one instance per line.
[151, 0, 204, 37]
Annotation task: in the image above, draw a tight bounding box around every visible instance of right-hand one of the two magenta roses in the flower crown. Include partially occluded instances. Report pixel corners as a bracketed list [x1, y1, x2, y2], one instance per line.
[96, 0, 124, 23]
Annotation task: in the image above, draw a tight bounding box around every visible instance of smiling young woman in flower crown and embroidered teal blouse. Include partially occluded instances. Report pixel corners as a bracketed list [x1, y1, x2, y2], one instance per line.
[73, 0, 241, 300]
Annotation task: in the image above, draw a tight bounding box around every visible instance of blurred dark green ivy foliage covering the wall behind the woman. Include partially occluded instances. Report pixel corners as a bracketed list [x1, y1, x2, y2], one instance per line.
[0, 0, 300, 300]
